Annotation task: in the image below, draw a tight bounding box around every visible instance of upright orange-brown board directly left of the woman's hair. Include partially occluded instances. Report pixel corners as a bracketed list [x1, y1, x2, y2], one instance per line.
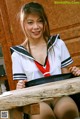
[5, 0, 24, 45]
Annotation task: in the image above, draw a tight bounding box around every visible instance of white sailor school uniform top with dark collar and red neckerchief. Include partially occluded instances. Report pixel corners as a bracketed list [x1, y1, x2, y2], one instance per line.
[11, 35, 73, 81]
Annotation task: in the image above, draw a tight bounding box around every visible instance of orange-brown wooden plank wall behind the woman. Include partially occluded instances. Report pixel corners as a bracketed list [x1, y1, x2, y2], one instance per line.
[0, 0, 80, 89]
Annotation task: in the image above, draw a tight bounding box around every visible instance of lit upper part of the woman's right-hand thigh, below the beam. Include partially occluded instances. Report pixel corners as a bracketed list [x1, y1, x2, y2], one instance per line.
[54, 96, 79, 115]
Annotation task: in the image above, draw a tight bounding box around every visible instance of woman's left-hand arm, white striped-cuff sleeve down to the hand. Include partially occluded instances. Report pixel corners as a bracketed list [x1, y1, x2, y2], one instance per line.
[11, 52, 27, 89]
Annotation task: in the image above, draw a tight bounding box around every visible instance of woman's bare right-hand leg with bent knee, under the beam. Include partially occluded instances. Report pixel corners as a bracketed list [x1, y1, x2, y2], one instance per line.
[54, 97, 79, 119]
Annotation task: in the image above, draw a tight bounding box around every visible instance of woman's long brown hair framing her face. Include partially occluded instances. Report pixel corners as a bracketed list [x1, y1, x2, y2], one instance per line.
[20, 2, 50, 40]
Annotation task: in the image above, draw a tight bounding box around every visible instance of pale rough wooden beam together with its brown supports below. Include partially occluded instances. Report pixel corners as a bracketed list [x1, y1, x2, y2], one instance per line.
[0, 77, 80, 119]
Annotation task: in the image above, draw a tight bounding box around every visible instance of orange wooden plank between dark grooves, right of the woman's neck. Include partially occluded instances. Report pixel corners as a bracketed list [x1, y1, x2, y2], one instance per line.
[51, 23, 80, 41]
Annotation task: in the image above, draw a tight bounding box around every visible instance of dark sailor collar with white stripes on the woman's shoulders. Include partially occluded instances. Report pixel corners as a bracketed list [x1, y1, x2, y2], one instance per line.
[10, 34, 60, 59]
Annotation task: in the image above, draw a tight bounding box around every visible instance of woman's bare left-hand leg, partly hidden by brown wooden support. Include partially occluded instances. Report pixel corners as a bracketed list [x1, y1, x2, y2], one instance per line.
[30, 102, 55, 119]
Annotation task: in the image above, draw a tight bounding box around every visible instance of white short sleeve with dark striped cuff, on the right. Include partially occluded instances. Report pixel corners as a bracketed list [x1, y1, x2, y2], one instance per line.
[61, 40, 73, 68]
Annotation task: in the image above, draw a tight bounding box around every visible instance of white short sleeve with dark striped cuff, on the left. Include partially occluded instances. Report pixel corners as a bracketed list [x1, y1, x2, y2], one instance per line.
[11, 52, 27, 80]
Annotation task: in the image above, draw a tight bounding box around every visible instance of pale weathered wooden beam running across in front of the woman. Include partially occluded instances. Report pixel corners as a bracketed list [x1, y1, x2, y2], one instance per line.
[0, 77, 80, 110]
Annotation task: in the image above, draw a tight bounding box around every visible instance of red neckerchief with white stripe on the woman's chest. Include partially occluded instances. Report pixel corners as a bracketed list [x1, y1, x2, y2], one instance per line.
[34, 57, 50, 77]
